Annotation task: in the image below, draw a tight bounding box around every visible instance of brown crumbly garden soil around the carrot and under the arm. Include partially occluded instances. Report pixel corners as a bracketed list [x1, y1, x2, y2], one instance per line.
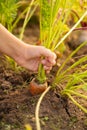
[0, 27, 87, 130]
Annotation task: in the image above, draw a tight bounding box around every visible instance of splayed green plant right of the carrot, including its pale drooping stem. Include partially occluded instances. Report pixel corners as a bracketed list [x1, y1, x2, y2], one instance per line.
[35, 42, 87, 130]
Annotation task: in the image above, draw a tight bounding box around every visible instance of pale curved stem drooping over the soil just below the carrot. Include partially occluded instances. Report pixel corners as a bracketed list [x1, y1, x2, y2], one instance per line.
[35, 86, 51, 130]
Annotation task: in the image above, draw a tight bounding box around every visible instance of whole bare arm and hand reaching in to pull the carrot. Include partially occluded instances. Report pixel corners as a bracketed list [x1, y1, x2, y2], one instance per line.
[0, 24, 56, 72]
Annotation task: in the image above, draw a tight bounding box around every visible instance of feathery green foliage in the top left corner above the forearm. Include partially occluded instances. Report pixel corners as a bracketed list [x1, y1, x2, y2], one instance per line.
[0, 0, 19, 31]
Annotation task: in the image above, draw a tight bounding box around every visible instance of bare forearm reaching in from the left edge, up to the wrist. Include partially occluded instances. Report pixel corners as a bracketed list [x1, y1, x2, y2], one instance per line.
[0, 24, 26, 59]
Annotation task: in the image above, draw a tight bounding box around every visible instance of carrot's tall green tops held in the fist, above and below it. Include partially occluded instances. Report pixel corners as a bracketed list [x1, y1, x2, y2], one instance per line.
[38, 0, 87, 81]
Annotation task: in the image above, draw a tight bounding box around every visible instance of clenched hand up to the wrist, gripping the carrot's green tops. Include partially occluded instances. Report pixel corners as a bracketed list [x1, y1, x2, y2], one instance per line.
[16, 44, 56, 73]
